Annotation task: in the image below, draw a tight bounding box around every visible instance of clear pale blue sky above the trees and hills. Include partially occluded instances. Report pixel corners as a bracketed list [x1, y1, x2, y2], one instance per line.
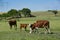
[0, 0, 60, 12]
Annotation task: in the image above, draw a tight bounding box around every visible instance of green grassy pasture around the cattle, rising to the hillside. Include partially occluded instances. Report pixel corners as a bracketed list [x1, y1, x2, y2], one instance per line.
[0, 12, 60, 40]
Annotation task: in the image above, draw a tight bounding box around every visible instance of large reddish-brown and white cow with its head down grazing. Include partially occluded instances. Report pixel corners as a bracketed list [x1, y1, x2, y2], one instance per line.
[30, 20, 50, 33]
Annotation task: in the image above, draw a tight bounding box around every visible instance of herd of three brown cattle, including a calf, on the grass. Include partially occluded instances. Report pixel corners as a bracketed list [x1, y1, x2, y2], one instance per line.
[8, 19, 51, 33]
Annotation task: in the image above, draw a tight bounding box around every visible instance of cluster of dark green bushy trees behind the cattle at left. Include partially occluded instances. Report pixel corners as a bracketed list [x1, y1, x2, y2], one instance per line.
[0, 8, 35, 18]
